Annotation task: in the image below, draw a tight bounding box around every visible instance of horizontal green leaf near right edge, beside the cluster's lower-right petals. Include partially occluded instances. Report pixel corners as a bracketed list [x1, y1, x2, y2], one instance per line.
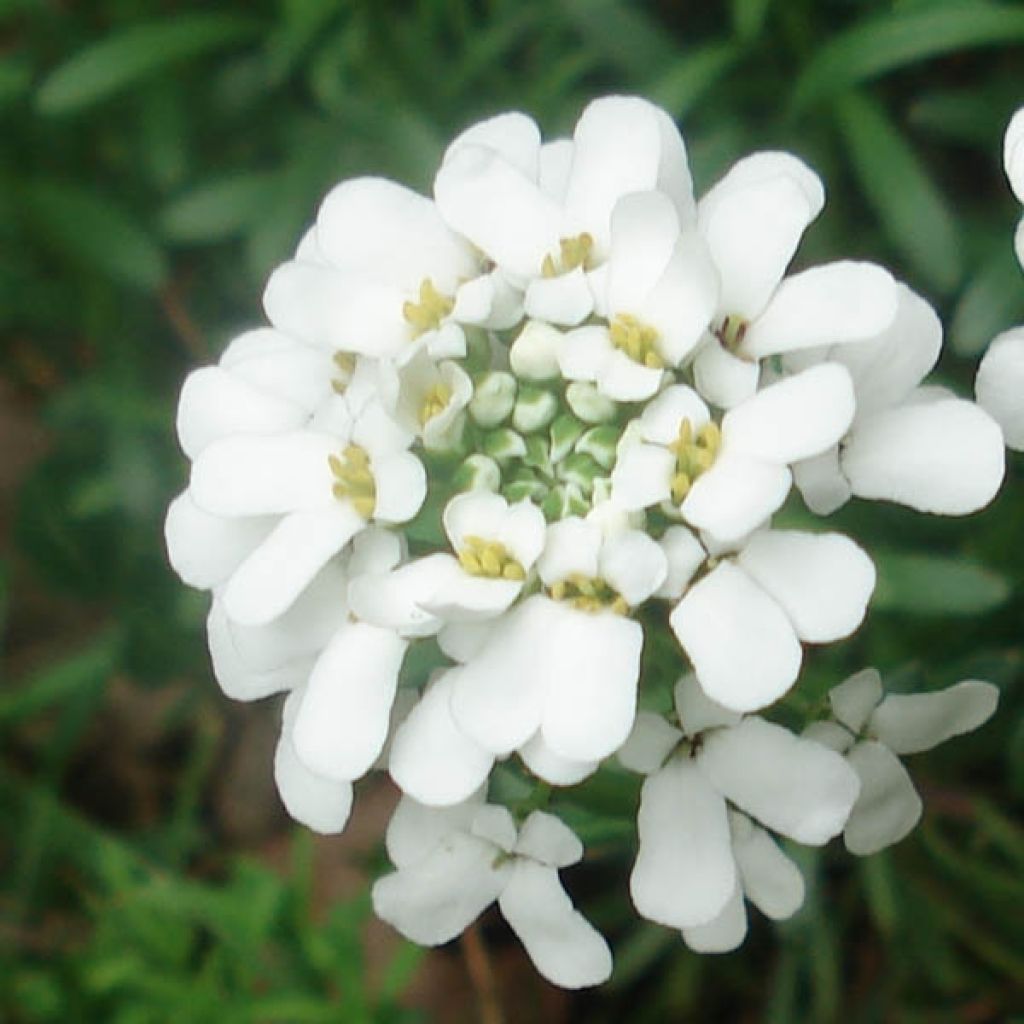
[873, 551, 1010, 615]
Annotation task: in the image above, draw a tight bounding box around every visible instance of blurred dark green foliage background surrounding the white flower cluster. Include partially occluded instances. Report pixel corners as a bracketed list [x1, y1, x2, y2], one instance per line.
[0, 0, 1024, 1024]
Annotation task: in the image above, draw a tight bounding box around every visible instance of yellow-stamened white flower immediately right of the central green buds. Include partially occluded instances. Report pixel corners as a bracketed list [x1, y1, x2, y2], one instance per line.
[611, 366, 854, 543]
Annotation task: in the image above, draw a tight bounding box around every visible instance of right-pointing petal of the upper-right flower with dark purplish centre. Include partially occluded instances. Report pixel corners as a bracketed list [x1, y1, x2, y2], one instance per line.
[740, 261, 898, 358]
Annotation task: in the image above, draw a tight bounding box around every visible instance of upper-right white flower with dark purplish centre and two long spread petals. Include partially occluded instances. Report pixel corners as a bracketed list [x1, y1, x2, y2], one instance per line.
[693, 153, 896, 409]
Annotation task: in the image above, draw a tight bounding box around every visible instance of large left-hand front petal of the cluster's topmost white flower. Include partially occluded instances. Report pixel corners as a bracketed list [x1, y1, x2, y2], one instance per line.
[434, 145, 562, 279]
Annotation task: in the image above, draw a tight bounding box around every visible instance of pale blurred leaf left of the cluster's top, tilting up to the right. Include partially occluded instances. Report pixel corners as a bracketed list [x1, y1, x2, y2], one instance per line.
[160, 171, 278, 242]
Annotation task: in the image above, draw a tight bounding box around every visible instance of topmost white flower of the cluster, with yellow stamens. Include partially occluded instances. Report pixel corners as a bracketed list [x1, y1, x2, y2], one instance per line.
[434, 96, 693, 325]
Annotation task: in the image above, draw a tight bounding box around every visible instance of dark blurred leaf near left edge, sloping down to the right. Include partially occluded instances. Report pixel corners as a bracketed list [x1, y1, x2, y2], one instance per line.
[25, 180, 167, 291]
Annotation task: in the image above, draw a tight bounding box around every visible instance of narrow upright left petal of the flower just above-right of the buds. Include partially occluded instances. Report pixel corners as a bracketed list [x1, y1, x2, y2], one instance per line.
[607, 191, 679, 314]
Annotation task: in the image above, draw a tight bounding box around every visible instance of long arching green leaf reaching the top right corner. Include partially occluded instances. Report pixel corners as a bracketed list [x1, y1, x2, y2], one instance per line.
[793, 2, 1024, 111]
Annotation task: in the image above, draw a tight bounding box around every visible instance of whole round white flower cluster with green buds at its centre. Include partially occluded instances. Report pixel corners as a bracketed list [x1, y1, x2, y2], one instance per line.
[166, 96, 1007, 987]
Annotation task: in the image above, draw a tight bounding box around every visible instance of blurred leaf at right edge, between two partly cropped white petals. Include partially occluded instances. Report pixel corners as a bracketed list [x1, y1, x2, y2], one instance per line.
[949, 239, 1024, 357]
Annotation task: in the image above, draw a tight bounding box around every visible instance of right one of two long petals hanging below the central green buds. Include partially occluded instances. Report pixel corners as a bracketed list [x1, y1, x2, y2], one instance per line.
[541, 607, 643, 761]
